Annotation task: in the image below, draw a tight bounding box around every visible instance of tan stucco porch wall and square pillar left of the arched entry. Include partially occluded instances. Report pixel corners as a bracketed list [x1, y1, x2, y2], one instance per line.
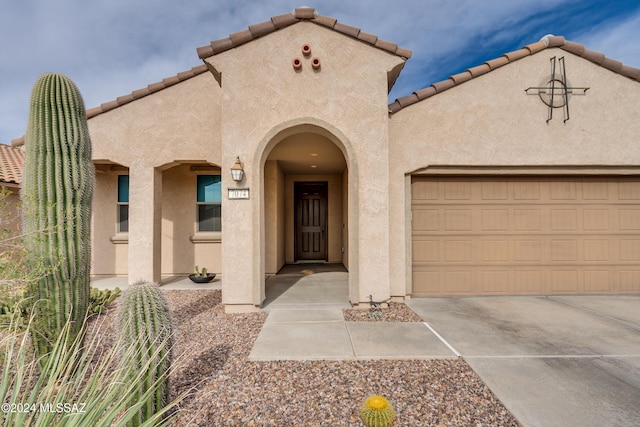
[89, 73, 221, 281]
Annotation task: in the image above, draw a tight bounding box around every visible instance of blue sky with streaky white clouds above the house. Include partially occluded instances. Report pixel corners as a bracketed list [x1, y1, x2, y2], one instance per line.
[0, 0, 640, 143]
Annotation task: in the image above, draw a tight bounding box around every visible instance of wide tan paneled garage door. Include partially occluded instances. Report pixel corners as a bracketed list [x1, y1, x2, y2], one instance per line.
[412, 177, 640, 296]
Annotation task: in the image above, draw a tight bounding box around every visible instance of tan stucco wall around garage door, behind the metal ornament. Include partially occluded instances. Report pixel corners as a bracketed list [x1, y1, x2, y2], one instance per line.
[389, 49, 640, 295]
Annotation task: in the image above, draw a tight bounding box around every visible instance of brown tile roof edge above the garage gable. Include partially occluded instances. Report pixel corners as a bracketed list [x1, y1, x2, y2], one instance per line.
[389, 35, 640, 114]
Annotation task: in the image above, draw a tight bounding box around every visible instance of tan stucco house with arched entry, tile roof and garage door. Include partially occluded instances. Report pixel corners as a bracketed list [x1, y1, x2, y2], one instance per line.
[5, 8, 640, 311]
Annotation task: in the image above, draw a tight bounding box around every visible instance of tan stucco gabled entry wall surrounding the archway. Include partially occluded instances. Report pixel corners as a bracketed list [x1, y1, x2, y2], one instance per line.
[206, 22, 403, 308]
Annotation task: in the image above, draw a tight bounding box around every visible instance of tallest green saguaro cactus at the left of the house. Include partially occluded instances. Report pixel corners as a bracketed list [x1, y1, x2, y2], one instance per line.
[22, 73, 94, 356]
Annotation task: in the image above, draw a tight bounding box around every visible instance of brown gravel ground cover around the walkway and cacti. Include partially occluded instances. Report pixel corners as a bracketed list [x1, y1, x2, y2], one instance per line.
[88, 290, 519, 427]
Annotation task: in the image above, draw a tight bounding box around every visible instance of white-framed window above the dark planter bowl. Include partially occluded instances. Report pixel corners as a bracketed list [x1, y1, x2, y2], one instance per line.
[196, 175, 222, 232]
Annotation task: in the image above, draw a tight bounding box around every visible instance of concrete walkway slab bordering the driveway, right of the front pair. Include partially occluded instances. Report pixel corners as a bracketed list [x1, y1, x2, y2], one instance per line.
[346, 322, 456, 359]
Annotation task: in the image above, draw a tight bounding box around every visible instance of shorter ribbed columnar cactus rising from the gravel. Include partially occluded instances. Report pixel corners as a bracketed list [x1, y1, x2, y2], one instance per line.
[118, 281, 172, 426]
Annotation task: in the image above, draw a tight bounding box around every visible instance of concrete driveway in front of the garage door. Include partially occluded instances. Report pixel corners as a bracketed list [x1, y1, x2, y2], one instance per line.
[408, 296, 640, 427]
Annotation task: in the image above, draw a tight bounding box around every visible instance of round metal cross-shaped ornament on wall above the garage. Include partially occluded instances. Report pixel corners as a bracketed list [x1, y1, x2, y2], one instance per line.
[524, 56, 589, 124]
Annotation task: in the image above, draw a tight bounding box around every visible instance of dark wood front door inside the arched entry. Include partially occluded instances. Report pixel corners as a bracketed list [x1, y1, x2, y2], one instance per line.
[294, 182, 328, 261]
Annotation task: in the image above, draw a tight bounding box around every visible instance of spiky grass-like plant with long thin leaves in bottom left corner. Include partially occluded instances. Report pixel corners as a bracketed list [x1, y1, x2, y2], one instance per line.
[0, 308, 187, 427]
